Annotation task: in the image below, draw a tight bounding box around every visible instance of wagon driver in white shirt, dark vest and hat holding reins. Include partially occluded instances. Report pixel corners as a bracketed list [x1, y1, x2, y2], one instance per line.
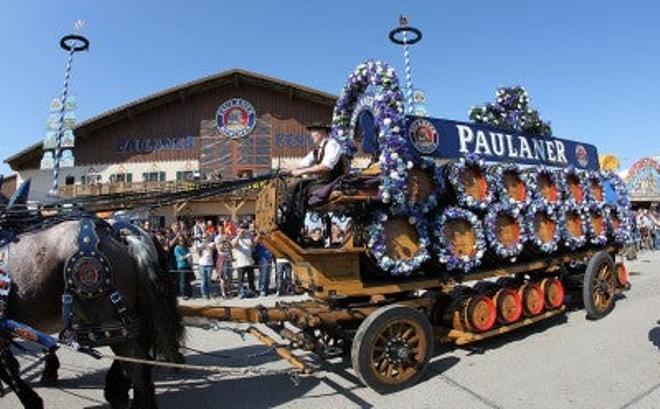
[289, 122, 350, 231]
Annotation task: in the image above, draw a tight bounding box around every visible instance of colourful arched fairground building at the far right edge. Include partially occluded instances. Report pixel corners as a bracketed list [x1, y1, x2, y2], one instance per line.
[619, 156, 660, 208]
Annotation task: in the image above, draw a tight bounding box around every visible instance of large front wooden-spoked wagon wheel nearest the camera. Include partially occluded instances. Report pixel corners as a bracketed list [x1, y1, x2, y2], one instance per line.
[351, 305, 433, 394]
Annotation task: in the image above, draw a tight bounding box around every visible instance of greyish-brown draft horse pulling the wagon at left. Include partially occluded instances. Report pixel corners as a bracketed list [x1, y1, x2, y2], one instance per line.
[0, 220, 183, 408]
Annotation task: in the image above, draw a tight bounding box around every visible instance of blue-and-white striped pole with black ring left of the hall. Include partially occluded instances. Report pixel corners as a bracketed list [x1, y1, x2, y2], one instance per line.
[50, 20, 89, 196]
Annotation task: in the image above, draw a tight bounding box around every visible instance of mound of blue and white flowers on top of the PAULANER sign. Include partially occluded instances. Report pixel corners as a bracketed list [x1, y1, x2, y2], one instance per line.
[468, 85, 552, 136]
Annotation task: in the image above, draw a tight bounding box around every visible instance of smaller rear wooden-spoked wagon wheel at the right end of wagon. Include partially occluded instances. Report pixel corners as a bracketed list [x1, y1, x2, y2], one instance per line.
[582, 251, 616, 320]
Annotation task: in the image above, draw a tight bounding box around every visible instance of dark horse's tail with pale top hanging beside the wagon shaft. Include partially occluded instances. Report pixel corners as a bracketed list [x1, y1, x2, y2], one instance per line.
[126, 233, 184, 362]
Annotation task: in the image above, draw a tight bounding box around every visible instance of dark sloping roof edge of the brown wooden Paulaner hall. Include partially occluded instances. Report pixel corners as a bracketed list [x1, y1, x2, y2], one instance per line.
[5, 68, 337, 169]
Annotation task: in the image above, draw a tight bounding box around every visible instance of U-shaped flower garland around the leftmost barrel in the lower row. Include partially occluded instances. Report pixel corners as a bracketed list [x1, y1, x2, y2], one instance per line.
[366, 210, 431, 276]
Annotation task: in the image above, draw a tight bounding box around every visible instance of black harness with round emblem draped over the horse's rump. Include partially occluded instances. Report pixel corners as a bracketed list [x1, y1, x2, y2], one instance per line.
[60, 218, 143, 347]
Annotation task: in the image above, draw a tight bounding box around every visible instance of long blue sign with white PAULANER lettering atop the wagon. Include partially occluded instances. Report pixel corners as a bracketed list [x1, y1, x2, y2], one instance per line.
[404, 116, 599, 169]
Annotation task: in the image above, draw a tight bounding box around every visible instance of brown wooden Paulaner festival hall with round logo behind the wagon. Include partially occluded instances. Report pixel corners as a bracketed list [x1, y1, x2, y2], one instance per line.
[5, 69, 365, 224]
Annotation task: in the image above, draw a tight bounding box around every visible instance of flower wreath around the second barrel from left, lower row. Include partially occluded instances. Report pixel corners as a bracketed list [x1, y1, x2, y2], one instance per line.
[433, 207, 486, 273]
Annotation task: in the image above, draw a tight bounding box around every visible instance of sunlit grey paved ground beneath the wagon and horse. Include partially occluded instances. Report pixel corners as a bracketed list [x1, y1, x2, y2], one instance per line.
[5, 252, 660, 409]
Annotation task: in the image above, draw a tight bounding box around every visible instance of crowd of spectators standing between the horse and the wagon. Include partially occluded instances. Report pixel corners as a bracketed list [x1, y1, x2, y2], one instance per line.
[151, 218, 292, 299]
